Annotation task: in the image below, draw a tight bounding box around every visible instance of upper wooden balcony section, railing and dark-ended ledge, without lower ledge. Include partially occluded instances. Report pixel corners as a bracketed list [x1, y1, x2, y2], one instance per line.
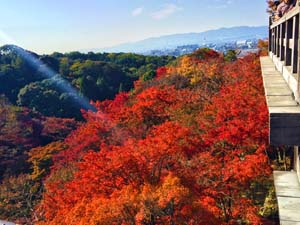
[268, 5, 300, 146]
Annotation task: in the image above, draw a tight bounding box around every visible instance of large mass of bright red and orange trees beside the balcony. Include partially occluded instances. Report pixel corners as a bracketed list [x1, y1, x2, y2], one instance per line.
[35, 49, 270, 225]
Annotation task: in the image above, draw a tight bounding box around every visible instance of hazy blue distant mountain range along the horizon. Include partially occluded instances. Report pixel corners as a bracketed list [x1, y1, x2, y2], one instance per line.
[85, 26, 268, 53]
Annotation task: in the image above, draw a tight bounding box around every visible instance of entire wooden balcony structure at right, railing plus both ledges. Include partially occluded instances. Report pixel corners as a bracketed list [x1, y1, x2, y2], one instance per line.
[266, 2, 300, 225]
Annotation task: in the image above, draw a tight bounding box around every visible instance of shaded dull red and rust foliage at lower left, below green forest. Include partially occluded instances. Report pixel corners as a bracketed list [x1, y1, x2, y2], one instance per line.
[0, 96, 78, 224]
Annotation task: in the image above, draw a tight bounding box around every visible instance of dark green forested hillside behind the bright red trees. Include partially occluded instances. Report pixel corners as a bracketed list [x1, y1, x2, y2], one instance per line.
[0, 45, 174, 119]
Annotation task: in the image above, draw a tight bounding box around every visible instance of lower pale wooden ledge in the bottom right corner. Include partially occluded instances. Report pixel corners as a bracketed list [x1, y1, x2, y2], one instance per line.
[274, 171, 300, 225]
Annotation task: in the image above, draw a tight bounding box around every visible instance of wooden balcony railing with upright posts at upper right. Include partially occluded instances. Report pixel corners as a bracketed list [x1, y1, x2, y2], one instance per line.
[269, 3, 300, 102]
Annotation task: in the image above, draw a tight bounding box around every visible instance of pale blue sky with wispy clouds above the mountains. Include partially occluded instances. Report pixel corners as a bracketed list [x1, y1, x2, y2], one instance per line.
[0, 0, 268, 53]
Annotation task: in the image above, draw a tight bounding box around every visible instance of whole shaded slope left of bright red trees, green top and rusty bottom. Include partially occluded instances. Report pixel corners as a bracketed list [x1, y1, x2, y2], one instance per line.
[0, 45, 174, 224]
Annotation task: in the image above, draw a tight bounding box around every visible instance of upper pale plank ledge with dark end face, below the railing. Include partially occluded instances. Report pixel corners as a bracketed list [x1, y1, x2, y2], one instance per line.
[260, 56, 300, 146]
